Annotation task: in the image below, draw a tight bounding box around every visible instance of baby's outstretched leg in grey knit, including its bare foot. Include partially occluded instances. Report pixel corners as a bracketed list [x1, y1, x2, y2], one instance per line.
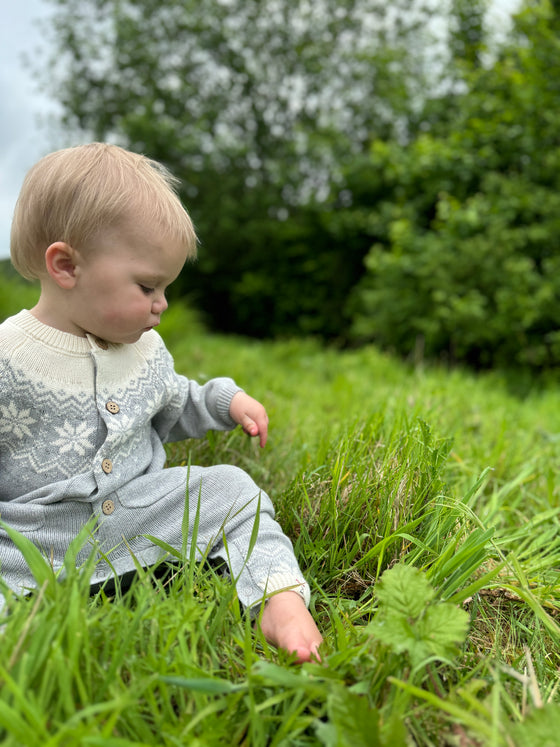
[93, 465, 322, 661]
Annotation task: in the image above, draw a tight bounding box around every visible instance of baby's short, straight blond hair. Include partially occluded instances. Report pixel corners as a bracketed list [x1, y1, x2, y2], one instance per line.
[10, 143, 196, 280]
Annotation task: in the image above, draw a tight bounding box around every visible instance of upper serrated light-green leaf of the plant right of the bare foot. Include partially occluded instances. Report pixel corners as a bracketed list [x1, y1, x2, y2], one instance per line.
[375, 563, 435, 617]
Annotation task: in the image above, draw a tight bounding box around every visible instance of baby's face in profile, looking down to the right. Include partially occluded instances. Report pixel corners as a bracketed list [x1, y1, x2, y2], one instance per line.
[72, 222, 186, 343]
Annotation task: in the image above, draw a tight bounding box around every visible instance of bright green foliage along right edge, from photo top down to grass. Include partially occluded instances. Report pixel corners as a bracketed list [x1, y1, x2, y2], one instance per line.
[347, 2, 560, 369]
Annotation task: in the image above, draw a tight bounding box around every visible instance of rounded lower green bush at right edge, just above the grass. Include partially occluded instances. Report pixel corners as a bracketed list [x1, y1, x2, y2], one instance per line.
[353, 168, 560, 368]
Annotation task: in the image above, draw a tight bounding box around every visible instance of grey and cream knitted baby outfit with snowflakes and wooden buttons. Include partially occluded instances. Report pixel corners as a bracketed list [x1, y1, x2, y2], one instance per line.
[0, 310, 309, 606]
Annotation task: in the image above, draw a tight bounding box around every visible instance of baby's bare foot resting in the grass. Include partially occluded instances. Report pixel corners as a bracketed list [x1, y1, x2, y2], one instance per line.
[260, 591, 323, 663]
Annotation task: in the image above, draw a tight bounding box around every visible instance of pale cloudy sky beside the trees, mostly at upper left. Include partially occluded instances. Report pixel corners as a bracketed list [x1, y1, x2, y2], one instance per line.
[0, 0, 518, 259]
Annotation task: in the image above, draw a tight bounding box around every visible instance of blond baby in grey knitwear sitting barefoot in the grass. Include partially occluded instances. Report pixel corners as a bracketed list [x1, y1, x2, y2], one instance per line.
[0, 143, 322, 661]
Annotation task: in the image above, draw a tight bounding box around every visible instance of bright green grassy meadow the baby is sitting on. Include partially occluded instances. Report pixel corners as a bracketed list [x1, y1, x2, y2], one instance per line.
[0, 292, 560, 747]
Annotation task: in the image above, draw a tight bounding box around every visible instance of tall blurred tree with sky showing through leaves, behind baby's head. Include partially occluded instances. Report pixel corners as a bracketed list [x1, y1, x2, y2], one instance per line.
[40, 0, 442, 336]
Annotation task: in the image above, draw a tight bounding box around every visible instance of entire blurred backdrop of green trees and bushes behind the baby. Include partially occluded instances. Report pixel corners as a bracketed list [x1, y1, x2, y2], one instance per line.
[32, 0, 560, 370]
